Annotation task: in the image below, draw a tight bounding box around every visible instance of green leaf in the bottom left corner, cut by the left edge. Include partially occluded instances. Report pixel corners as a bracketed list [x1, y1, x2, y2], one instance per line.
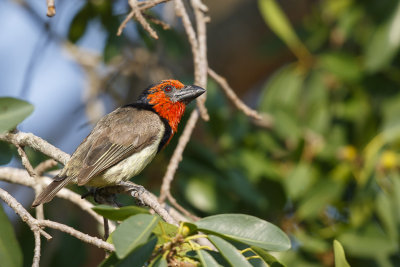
[0, 205, 22, 267]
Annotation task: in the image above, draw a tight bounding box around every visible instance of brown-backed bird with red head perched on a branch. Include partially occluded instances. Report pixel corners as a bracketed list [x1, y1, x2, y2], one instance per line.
[32, 79, 206, 207]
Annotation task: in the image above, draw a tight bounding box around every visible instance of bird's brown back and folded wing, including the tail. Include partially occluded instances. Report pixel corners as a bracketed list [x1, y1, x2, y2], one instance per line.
[32, 107, 165, 207]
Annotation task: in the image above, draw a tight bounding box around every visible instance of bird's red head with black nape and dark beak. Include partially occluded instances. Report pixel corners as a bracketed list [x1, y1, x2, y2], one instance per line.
[138, 80, 205, 133]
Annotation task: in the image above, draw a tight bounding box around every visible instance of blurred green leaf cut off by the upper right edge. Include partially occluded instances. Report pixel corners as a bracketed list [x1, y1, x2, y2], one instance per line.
[365, 2, 400, 72]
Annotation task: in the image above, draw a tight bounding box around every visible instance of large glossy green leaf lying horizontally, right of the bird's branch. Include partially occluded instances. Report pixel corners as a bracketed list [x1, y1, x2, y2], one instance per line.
[194, 214, 290, 251]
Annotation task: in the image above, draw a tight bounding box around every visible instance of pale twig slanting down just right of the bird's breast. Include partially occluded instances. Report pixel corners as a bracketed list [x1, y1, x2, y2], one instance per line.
[159, 109, 199, 203]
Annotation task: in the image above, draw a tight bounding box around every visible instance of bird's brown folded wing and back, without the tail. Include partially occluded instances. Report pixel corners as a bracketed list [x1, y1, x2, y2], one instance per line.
[71, 107, 164, 185]
